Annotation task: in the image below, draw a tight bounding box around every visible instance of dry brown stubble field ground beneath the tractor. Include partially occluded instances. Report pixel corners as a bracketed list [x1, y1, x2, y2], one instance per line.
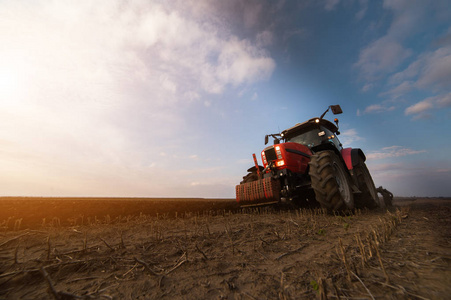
[0, 198, 451, 299]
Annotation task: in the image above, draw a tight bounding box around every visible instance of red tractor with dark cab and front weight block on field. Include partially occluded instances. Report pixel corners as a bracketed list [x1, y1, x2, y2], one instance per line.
[236, 105, 384, 211]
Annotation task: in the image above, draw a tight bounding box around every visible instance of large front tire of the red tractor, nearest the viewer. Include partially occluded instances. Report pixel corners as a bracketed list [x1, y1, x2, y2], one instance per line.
[309, 150, 354, 212]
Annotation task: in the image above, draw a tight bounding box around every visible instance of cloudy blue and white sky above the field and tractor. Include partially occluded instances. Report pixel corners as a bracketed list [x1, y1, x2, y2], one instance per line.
[0, 0, 451, 198]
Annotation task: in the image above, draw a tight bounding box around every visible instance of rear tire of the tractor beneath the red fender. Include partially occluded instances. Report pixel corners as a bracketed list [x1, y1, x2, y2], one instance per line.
[354, 158, 385, 209]
